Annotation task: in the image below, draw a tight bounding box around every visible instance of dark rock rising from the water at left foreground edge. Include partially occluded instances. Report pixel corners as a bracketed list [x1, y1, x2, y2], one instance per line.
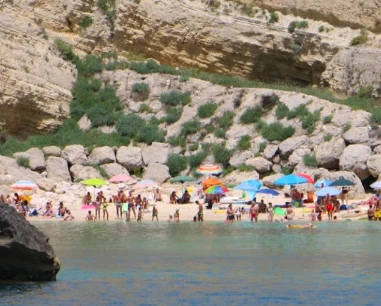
[0, 203, 61, 281]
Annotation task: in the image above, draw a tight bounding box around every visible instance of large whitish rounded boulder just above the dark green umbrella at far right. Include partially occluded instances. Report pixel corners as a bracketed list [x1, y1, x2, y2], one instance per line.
[339, 144, 371, 180]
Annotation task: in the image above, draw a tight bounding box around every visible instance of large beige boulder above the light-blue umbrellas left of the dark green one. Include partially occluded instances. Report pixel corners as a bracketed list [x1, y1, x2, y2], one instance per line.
[315, 137, 345, 170]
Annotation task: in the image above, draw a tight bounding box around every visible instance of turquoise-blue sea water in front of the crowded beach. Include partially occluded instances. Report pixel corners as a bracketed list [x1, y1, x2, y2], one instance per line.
[0, 221, 381, 305]
